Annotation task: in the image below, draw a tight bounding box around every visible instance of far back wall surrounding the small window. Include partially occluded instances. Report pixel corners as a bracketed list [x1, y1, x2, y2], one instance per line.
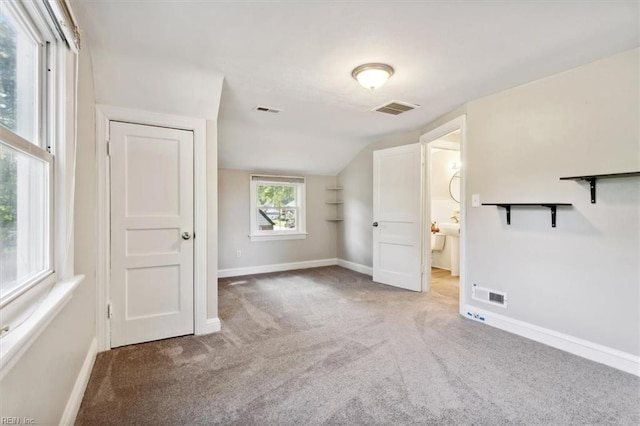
[218, 169, 337, 270]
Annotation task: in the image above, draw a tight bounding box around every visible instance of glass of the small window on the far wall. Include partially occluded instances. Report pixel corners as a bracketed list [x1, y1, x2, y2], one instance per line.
[257, 184, 298, 231]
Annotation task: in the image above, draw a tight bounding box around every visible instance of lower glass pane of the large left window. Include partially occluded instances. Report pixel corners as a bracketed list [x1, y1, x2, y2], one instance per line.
[0, 143, 49, 299]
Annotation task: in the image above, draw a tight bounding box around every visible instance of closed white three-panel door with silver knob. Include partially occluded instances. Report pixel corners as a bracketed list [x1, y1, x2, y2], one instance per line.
[109, 121, 193, 347]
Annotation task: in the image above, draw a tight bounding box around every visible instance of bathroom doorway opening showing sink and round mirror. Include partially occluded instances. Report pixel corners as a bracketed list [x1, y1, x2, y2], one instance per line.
[420, 117, 464, 307]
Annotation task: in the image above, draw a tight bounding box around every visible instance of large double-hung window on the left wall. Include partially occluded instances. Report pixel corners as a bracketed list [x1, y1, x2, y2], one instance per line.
[0, 1, 53, 307]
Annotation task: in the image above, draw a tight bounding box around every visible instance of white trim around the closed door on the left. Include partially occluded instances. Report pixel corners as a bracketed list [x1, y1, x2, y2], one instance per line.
[96, 105, 210, 351]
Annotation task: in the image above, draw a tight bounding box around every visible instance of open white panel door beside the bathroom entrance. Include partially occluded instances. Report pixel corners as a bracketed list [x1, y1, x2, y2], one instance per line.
[373, 143, 422, 291]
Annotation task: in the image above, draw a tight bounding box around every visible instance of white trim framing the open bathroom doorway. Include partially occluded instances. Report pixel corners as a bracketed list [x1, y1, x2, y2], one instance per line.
[420, 114, 467, 315]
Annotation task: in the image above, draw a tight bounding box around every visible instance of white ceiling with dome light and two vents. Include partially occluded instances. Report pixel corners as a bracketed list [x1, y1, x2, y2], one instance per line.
[73, 0, 639, 175]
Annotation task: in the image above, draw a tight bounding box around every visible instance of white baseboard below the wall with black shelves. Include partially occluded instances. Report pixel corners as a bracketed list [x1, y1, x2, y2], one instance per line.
[460, 305, 640, 376]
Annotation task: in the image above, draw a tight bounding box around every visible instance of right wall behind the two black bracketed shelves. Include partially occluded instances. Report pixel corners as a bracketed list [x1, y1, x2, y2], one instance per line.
[466, 49, 640, 355]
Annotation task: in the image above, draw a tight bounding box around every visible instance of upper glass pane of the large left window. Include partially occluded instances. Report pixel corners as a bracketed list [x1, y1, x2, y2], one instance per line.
[0, 7, 39, 144]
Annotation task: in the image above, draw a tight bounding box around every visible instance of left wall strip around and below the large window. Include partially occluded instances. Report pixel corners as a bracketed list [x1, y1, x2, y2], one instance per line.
[0, 46, 96, 425]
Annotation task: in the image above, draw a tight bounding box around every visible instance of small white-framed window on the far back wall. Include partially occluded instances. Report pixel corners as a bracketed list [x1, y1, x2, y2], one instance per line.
[250, 175, 307, 241]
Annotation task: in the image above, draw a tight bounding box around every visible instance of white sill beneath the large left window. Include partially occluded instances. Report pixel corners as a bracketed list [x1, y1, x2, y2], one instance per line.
[0, 275, 84, 380]
